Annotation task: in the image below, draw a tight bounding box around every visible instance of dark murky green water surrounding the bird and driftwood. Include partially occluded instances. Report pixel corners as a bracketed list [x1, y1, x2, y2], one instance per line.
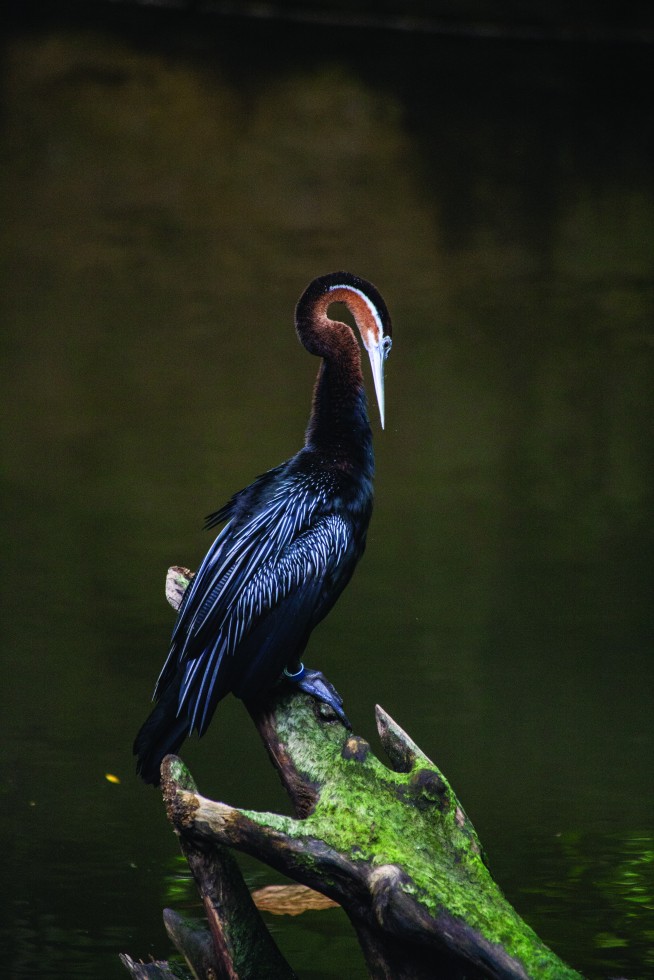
[0, 11, 654, 980]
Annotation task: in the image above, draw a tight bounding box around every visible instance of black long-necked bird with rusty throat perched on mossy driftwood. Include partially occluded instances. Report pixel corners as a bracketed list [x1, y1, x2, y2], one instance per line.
[134, 272, 392, 786]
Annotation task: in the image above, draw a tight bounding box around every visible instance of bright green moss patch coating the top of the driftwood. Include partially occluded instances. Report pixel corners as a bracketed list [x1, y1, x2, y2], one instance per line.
[237, 694, 579, 980]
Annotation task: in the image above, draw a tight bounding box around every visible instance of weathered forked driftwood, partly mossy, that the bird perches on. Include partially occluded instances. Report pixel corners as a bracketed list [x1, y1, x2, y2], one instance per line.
[124, 569, 580, 980]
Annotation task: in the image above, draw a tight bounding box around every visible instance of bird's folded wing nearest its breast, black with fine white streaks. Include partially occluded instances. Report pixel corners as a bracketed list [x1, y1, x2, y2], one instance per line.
[179, 514, 355, 734]
